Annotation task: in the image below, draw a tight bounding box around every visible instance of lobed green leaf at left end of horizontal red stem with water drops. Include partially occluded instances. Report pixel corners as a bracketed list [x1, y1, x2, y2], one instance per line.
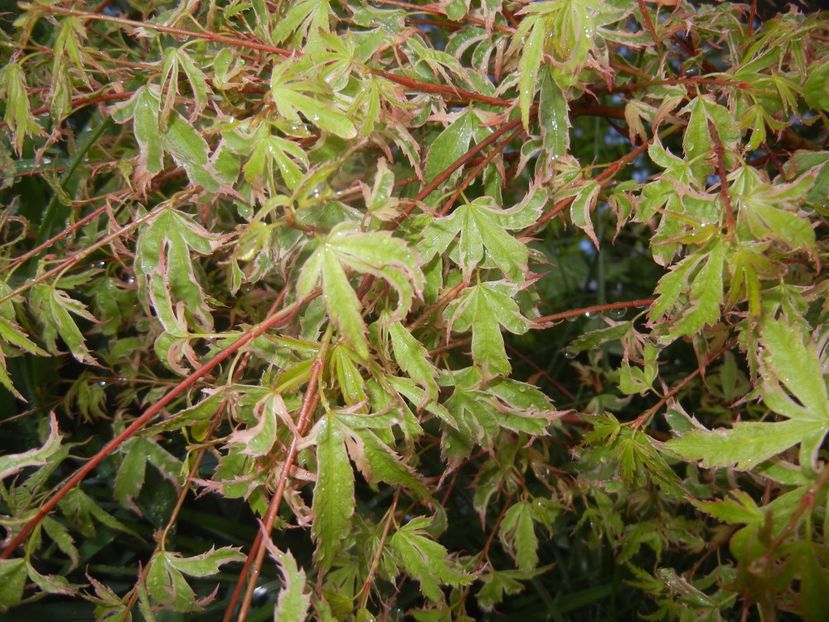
[445, 281, 527, 377]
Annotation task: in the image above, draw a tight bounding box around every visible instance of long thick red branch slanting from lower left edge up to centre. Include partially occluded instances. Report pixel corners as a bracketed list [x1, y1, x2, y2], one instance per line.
[0, 292, 320, 559]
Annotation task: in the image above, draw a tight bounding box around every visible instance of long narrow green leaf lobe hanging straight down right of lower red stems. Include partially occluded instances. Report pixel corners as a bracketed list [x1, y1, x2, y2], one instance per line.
[312, 414, 354, 568]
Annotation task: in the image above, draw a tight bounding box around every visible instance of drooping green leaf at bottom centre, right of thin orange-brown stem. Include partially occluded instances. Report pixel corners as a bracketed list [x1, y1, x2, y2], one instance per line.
[389, 517, 472, 603]
